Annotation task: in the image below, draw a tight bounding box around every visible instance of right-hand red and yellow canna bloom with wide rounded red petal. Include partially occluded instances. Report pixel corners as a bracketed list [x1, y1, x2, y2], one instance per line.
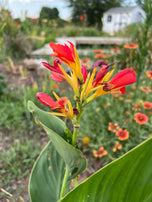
[81, 60, 136, 103]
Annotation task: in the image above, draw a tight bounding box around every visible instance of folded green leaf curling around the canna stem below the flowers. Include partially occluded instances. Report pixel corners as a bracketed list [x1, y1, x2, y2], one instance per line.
[28, 101, 86, 179]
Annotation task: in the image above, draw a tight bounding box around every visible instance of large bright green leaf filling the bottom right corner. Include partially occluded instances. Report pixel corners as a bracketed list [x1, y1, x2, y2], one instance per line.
[61, 139, 152, 202]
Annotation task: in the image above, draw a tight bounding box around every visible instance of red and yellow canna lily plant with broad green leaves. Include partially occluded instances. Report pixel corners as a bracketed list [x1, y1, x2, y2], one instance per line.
[28, 41, 152, 202]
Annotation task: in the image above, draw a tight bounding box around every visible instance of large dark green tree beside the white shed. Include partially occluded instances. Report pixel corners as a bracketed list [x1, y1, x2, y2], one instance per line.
[67, 0, 124, 28]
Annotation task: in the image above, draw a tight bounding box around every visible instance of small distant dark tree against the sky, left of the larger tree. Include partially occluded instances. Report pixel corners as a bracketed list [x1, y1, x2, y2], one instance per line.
[39, 7, 59, 21]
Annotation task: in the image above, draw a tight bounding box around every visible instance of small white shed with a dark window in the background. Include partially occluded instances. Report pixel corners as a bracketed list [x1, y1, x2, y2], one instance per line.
[102, 6, 146, 34]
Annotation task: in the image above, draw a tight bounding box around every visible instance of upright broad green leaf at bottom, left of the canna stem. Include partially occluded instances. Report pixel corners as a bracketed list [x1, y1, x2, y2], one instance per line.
[29, 142, 65, 202]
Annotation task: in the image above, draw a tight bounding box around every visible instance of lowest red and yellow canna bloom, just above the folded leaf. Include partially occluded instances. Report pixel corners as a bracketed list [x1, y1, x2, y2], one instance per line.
[36, 92, 73, 119]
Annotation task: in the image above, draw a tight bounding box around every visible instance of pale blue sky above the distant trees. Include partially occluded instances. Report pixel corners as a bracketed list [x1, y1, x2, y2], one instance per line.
[0, 0, 71, 20]
